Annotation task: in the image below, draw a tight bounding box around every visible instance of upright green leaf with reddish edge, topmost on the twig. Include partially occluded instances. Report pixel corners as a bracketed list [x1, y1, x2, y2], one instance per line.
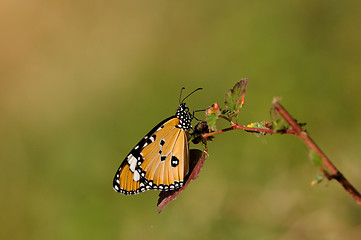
[224, 78, 248, 115]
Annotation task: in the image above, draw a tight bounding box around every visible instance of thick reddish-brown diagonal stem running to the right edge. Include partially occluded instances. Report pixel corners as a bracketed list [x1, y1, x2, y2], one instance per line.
[273, 100, 361, 206]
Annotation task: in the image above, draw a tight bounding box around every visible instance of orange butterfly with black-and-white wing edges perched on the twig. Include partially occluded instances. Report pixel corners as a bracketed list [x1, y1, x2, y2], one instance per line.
[113, 88, 201, 195]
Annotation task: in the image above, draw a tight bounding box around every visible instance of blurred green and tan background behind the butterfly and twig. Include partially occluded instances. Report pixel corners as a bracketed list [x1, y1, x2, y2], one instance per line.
[0, 0, 361, 240]
